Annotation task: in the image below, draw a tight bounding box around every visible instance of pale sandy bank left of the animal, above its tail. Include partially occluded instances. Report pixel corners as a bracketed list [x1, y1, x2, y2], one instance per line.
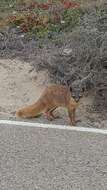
[0, 59, 47, 117]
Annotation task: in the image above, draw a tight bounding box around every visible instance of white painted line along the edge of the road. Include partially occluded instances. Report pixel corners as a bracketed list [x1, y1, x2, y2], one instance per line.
[0, 120, 107, 135]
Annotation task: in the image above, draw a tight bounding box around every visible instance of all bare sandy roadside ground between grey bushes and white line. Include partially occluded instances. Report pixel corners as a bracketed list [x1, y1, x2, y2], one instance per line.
[0, 59, 107, 128]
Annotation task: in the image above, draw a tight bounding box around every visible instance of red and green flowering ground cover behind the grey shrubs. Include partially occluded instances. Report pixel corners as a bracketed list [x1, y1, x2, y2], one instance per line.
[1, 0, 83, 38]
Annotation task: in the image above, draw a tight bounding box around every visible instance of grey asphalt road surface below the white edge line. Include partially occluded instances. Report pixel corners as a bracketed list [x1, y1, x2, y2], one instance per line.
[0, 125, 107, 190]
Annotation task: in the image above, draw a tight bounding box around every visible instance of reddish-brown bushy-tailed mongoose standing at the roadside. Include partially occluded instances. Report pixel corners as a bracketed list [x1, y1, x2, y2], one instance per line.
[16, 84, 82, 125]
